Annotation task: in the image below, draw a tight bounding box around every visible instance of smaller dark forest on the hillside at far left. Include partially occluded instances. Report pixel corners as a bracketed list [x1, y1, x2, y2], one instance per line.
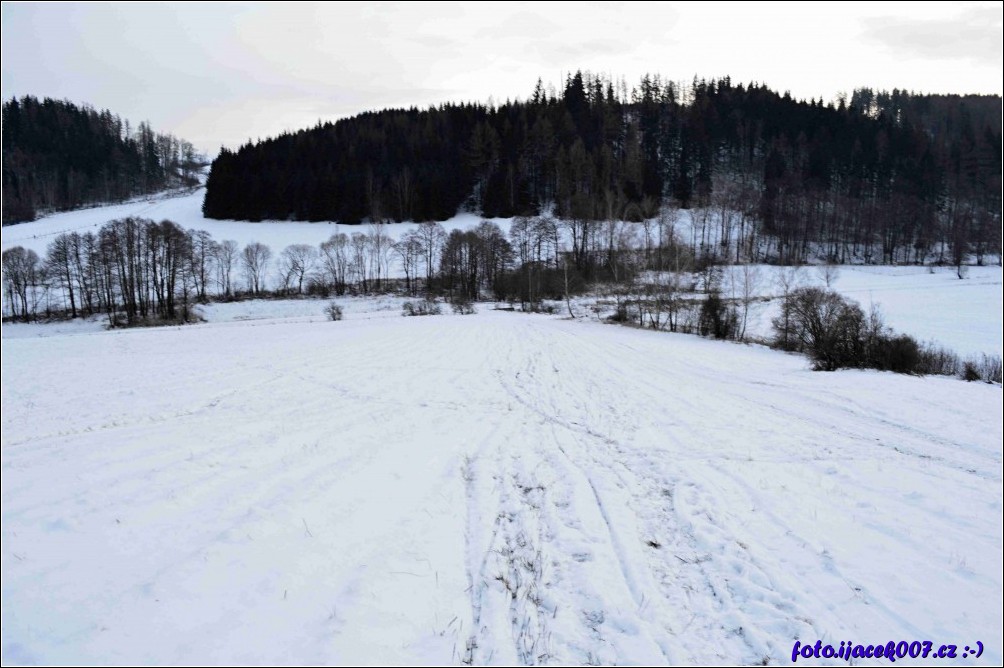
[3, 96, 208, 225]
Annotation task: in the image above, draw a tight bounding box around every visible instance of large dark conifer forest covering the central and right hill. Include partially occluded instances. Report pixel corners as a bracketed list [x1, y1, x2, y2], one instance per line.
[203, 72, 1001, 263]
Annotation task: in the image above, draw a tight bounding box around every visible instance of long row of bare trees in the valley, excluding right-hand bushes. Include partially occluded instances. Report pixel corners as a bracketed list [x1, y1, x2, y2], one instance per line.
[3, 209, 827, 321]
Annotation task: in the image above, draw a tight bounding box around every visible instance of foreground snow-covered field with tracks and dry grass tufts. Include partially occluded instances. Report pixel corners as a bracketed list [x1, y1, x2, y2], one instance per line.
[2, 311, 1004, 664]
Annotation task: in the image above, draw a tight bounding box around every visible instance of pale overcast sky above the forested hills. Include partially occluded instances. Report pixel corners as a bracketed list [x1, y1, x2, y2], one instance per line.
[2, 2, 1004, 156]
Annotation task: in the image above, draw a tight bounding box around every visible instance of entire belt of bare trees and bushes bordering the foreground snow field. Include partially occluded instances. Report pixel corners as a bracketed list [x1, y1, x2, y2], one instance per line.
[3, 212, 1001, 383]
